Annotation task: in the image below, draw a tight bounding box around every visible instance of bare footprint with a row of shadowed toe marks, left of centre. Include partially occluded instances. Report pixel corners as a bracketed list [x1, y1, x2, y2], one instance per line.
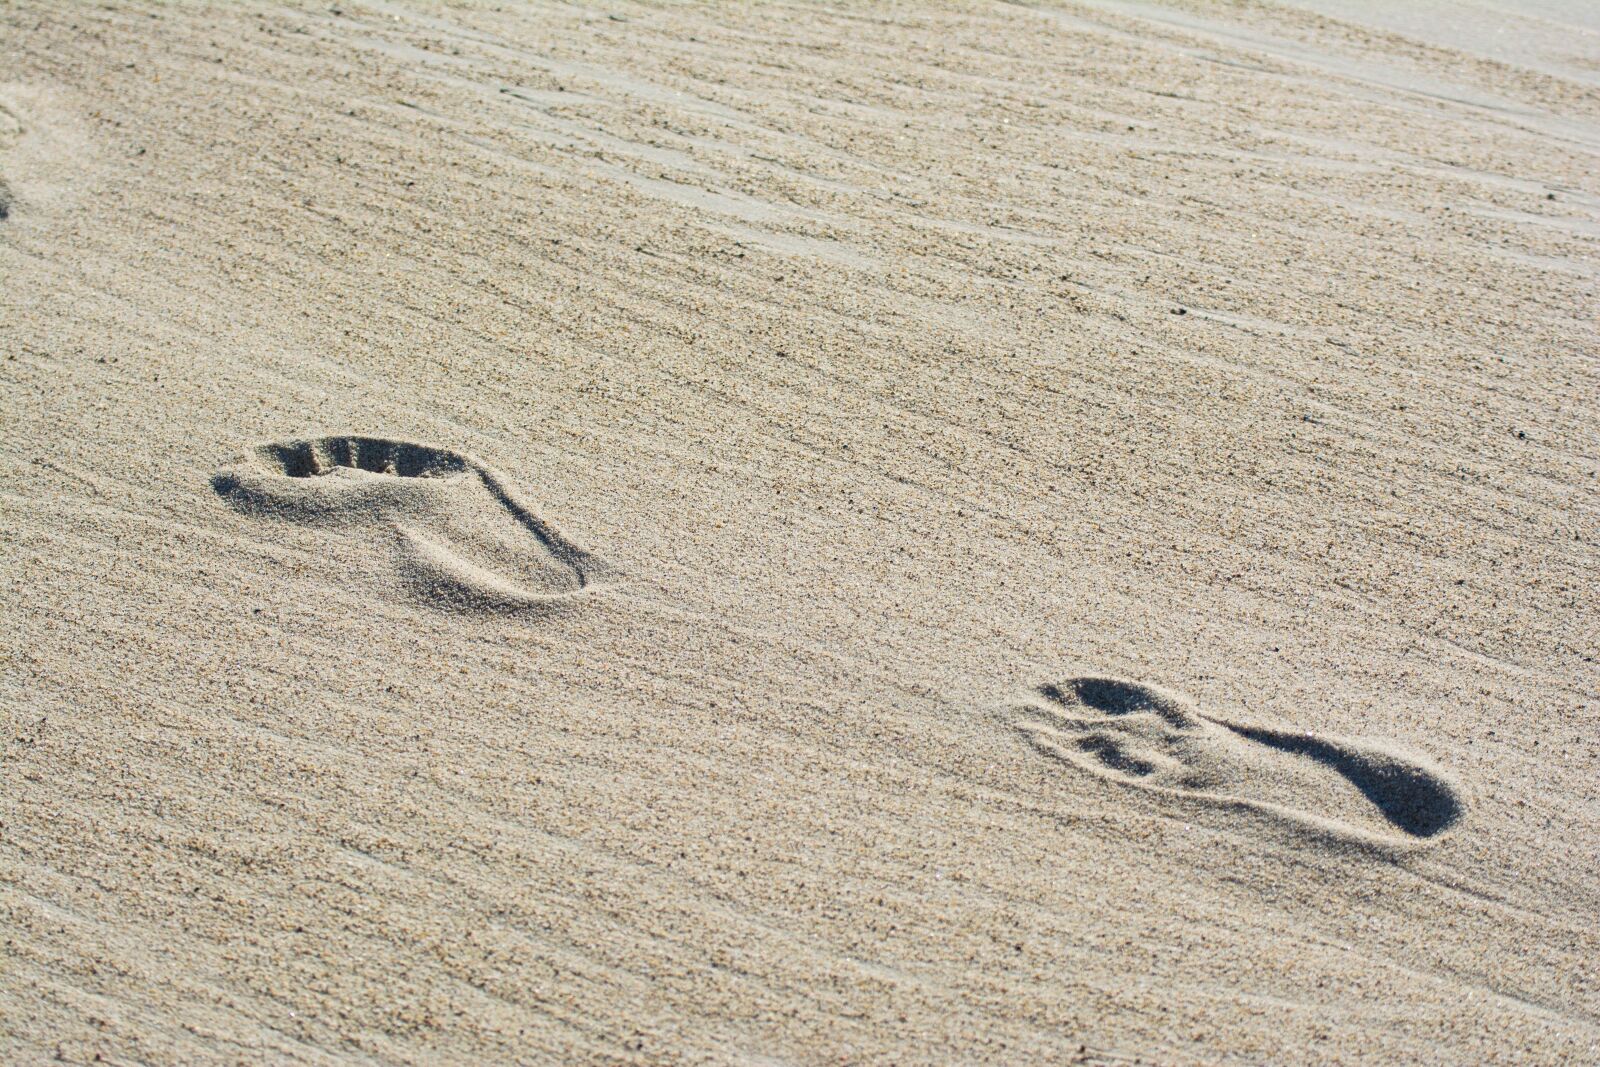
[211, 437, 605, 609]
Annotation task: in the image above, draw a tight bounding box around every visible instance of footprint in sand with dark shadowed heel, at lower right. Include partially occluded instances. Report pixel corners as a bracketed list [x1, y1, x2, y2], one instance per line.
[1016, 678, 1466, 848]
